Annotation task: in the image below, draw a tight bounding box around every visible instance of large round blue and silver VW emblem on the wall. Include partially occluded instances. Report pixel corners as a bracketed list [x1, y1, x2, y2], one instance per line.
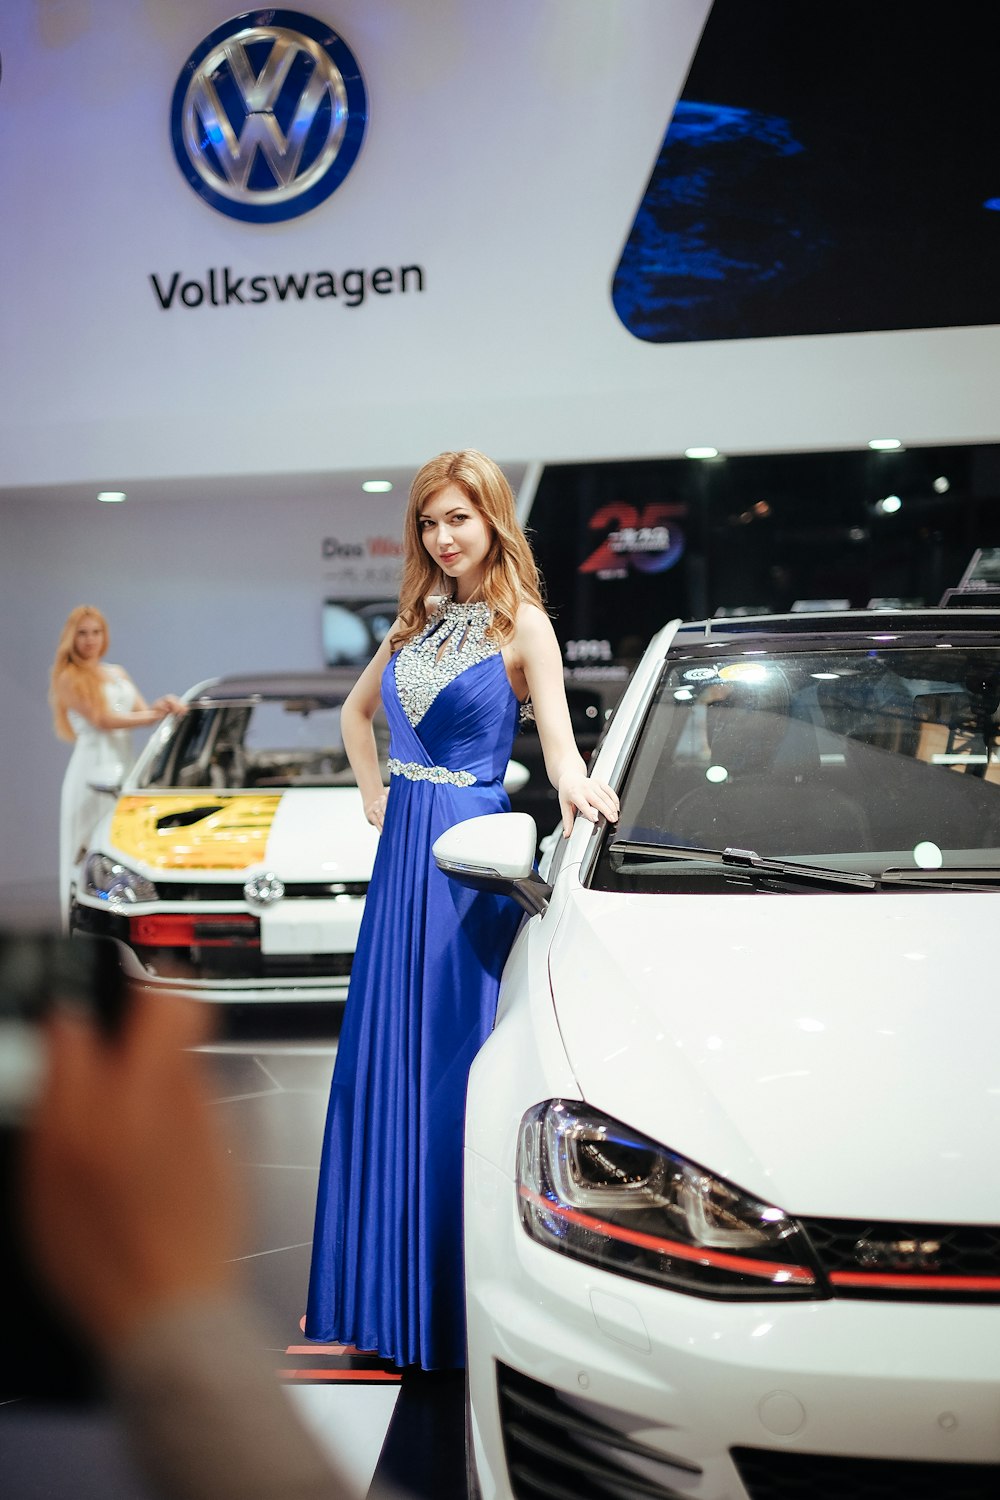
[171, 11, 367, 224]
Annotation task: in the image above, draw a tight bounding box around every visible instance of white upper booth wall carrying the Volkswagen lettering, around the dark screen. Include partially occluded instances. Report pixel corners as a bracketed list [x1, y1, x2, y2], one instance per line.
[0, 0, 1000, 489]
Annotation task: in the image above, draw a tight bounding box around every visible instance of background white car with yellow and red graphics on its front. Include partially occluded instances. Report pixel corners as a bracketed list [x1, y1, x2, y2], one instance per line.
[70, 669, 379, 1002]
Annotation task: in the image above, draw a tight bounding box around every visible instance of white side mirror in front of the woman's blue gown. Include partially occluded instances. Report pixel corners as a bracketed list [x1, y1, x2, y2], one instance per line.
[432, 813, 552, 917]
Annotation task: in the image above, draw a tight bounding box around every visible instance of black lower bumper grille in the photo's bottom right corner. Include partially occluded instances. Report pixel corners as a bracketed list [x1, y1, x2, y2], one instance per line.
[730, 1448, 1000, 1500]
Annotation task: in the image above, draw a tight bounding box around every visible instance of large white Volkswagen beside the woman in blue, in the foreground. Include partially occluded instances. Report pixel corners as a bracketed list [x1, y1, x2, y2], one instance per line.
[435, 609, 1000, 1500]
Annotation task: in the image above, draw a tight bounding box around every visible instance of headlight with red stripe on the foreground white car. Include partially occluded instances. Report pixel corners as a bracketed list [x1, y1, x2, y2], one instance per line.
[517, 1100, 828, 1298]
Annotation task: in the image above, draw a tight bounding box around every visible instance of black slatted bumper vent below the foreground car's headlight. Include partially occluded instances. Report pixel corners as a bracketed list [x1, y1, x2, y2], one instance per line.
[496, 1365, 702, 1500]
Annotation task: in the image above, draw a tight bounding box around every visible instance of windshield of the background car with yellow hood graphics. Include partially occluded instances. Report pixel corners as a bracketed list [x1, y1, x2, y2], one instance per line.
[136, 696, 388, 792]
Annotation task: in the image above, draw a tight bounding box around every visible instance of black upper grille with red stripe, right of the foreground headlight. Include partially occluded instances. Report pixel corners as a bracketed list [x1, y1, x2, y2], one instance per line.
[799, 1218, 1000, 1302]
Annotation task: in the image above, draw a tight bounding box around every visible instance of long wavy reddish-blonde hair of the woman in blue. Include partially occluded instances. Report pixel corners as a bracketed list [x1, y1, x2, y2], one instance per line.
[390, 449, 544, 651]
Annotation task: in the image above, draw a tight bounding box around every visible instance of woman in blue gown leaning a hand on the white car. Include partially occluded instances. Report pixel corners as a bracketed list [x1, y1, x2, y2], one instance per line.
[306, 450, 618, 1370]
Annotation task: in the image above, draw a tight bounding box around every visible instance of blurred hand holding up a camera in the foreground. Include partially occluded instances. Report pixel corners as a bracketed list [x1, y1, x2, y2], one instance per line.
[22, 989, 243, 1355]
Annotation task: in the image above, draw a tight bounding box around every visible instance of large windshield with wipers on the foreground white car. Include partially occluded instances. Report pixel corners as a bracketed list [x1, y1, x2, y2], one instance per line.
[592, 638, 1000, 891]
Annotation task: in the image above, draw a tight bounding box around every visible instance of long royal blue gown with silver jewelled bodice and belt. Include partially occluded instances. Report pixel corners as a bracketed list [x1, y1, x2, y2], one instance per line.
[306, 602, 520, 1370]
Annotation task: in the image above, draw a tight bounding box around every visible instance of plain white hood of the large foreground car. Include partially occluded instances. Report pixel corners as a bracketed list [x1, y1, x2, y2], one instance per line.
[549, 888, 1000, 1224]
